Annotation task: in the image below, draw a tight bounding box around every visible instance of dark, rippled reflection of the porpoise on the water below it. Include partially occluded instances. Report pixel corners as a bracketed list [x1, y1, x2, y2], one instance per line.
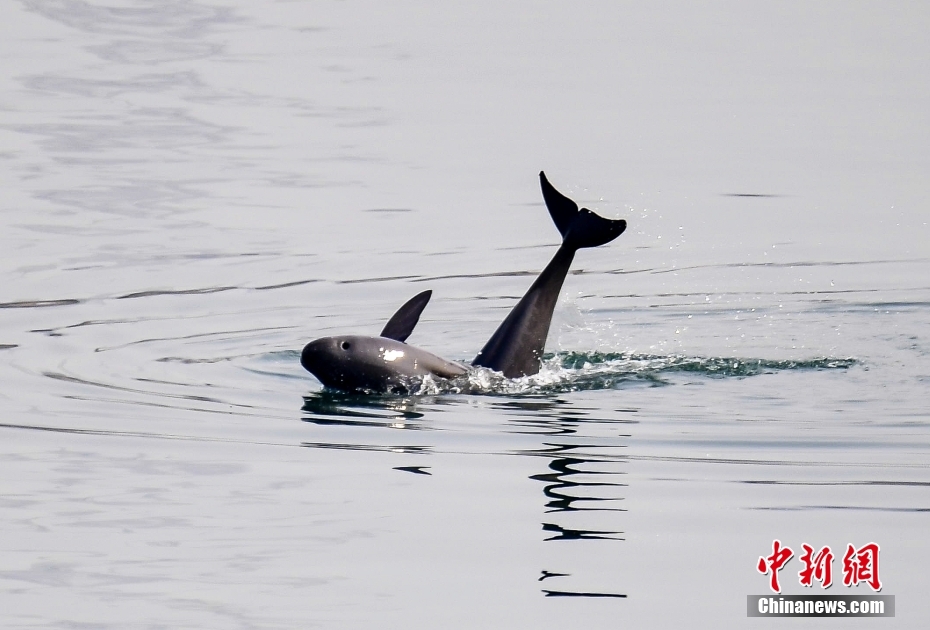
[301, 390, 636, 598]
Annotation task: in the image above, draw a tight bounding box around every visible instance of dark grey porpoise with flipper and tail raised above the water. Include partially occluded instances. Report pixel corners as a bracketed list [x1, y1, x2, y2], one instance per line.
[300, 172, 626, 392]
